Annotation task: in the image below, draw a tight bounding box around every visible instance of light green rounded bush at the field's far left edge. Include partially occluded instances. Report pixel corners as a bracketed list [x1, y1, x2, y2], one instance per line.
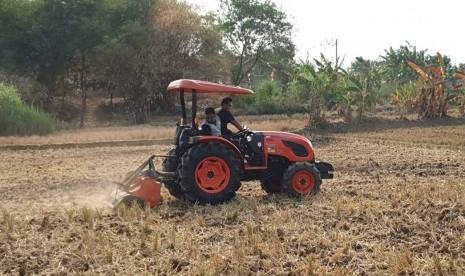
[0, 83, 55, 135]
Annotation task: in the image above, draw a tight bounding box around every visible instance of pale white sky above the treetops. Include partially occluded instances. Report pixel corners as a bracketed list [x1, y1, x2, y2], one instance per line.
[188, 0, 465, 66]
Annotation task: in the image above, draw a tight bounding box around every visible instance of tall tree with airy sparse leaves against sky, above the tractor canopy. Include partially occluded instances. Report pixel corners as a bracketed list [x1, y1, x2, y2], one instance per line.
[220, 0, 295, 85]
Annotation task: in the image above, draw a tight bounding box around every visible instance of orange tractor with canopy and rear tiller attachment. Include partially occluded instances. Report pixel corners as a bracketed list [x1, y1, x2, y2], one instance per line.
[113, 79, 334, 207]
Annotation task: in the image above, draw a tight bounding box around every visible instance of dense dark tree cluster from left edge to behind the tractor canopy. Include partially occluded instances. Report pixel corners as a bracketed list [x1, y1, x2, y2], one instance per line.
[0, 0, 229, 125]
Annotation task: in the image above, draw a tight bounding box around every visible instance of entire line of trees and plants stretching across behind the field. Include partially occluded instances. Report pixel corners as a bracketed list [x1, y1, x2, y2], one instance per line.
[0, 0, 465, 125]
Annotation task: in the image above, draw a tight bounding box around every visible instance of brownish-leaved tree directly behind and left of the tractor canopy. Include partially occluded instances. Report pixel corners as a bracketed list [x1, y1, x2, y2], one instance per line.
[93, 0, 226, 123]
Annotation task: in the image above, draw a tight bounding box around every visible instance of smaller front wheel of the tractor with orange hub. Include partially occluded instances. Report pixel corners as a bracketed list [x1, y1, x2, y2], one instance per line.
[281, 162, 321, 198]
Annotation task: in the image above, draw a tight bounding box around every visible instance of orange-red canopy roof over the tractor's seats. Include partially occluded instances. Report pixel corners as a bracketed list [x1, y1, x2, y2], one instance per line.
[168, 79, 254, 95]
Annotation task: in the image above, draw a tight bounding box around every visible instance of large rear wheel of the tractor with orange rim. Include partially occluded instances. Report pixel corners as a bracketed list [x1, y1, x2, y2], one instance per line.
[178, 143, 241, 204]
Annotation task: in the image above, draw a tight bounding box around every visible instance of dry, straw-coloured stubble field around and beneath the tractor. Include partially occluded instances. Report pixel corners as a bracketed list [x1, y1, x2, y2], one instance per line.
[0, 119, 465, 275]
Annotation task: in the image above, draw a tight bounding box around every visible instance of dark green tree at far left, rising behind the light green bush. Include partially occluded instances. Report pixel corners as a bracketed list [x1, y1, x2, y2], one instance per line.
[0, 0, 106, 125]
